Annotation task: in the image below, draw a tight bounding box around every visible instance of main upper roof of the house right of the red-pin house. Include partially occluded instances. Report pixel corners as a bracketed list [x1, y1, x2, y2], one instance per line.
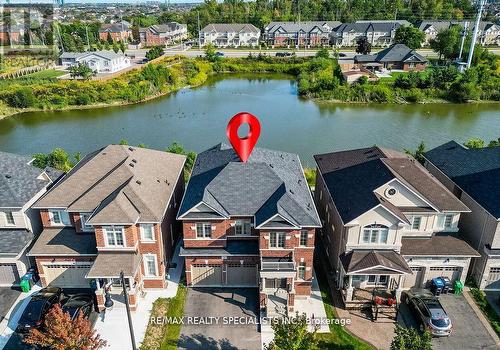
[314, 147, 468, 223]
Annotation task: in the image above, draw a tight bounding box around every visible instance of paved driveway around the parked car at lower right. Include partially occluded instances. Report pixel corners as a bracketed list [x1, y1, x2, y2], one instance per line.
[400, 294, 497, 350]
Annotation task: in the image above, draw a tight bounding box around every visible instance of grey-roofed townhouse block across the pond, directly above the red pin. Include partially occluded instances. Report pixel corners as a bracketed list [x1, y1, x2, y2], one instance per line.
[199, 23, 260, 47]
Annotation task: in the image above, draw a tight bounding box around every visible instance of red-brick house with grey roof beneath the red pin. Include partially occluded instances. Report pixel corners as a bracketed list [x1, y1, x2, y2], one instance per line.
[177, 144, 320, 315]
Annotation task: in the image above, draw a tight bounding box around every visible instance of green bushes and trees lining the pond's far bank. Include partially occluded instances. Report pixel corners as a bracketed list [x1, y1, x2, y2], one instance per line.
[0, 50, 500, 119]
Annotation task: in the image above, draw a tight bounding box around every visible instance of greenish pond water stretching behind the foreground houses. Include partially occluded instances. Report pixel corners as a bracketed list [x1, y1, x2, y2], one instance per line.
[0, 74, 500, 165]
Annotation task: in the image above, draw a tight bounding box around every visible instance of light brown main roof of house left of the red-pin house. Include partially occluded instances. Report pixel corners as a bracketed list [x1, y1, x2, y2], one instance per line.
[34, 145, 186, 224]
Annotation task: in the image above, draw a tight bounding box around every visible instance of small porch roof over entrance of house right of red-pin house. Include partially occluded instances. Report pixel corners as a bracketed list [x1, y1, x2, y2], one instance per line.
[340, 250, 412, 274]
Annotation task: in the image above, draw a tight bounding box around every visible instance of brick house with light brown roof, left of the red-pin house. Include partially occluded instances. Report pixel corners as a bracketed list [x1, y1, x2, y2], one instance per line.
[29, 145, 185, 309]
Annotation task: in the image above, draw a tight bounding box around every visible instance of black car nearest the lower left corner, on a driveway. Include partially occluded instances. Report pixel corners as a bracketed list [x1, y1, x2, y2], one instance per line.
[16, 287, 64, 333]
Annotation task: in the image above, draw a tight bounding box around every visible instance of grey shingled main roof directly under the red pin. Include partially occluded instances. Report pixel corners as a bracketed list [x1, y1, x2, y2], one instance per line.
[178, 143, 320, 227]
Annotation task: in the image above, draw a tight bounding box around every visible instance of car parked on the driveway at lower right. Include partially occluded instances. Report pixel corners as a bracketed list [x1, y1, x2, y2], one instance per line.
[403, 289, 453, 337]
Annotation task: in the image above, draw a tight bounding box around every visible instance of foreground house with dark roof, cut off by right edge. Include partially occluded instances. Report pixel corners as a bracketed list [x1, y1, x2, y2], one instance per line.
[424, 141, 500, 291]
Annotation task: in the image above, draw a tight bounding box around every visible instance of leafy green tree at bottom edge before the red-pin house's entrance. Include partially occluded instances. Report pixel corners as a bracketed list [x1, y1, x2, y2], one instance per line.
[265, 313, 318, 350]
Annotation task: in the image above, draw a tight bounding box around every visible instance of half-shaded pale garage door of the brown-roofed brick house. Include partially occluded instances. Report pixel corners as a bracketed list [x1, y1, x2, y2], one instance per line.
[43, 264, 92, 288]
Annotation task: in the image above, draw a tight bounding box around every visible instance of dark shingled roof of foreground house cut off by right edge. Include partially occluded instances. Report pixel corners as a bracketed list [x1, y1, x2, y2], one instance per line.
[424, 141, 500, 219]
